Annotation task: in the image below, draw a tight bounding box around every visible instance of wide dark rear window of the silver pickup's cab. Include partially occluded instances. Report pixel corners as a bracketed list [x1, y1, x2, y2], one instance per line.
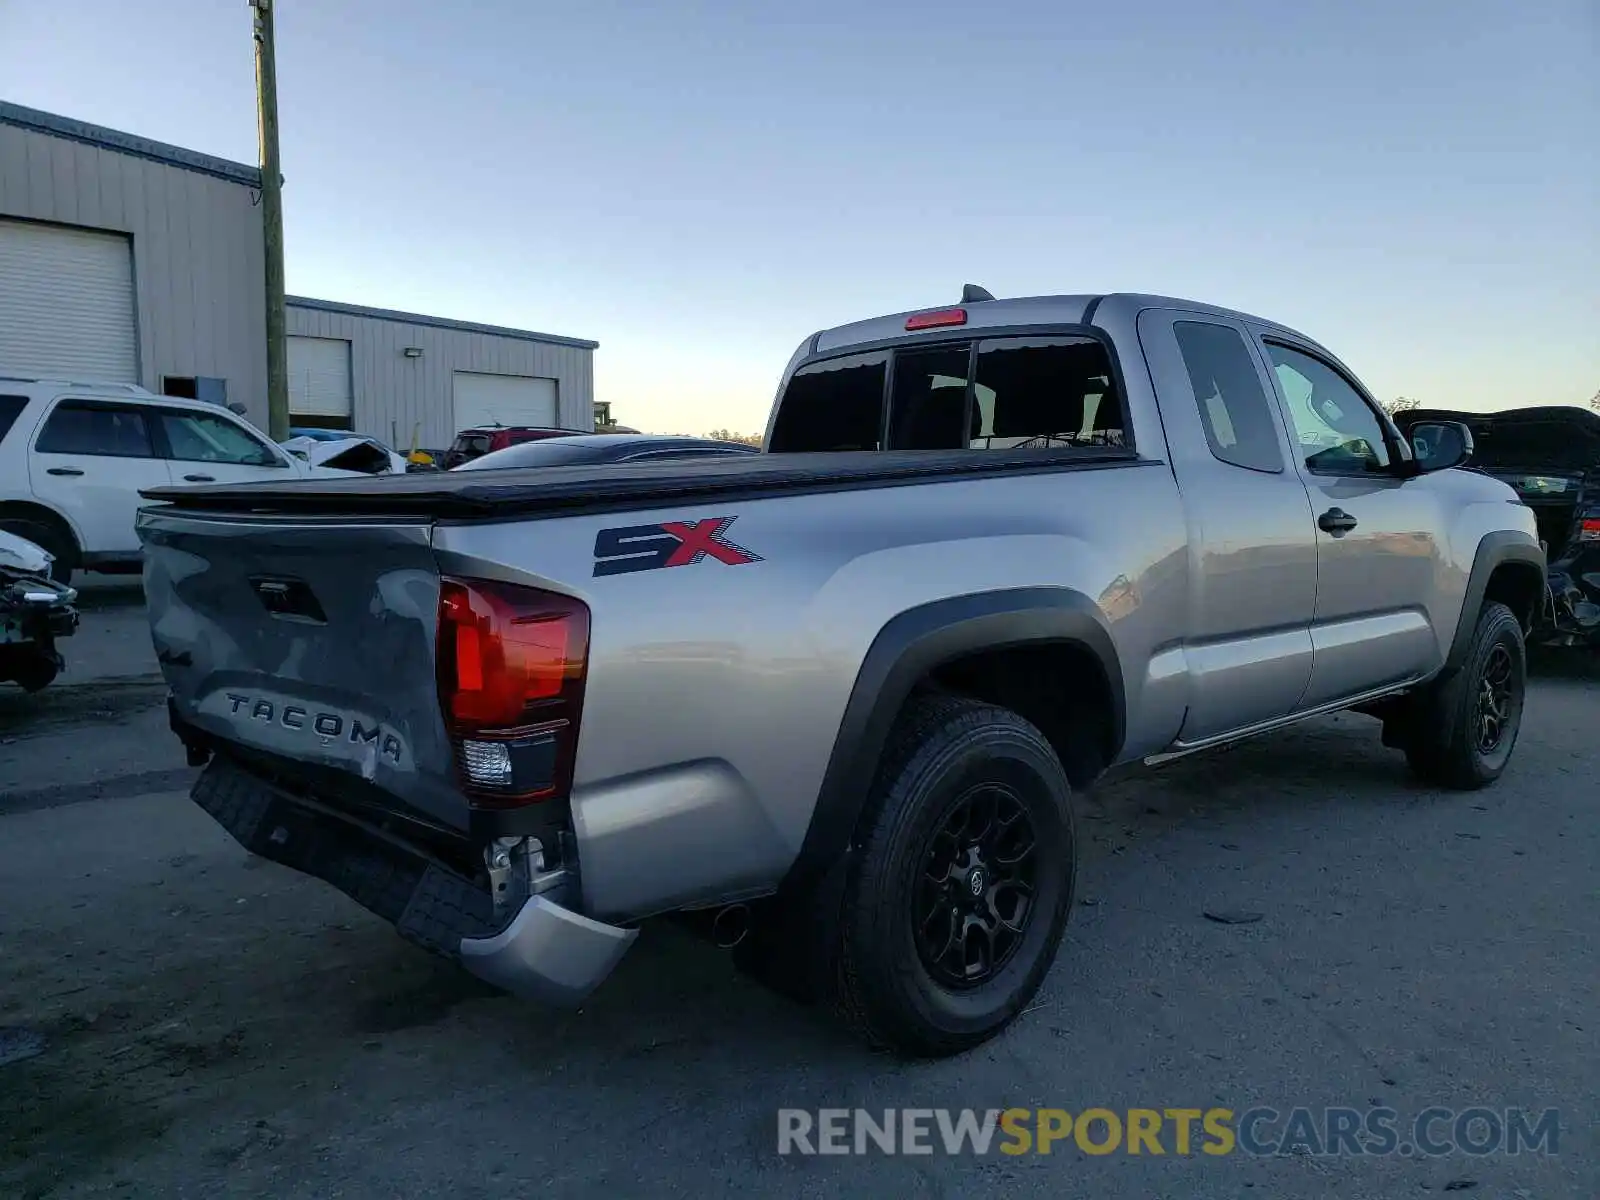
[771, 336, 1128, 453]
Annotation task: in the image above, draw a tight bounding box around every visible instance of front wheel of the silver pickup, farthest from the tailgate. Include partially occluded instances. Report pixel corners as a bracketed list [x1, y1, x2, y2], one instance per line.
[1405, 602, 1528, 790]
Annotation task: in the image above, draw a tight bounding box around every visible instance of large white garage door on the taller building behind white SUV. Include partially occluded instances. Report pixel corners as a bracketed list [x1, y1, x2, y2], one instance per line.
[0, 221, 139, 384]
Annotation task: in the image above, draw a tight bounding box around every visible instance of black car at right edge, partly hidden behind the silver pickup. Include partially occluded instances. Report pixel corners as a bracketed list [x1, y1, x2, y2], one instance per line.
[1395, 405, 1600, 646]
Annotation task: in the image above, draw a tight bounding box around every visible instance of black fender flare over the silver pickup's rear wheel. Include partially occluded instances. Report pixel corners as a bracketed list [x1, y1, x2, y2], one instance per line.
[782, 587, 1126, 891]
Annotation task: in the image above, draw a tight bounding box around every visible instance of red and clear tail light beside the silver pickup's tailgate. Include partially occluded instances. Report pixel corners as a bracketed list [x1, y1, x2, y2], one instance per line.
[435, 578, 589, 808]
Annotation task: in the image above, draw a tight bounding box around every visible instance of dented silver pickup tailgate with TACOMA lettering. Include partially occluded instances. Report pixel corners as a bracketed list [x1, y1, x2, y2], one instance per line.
[139, 507, 469, 830]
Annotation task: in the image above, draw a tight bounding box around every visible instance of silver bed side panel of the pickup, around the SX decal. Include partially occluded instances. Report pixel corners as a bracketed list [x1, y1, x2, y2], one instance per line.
[434, 462, 1186, 917]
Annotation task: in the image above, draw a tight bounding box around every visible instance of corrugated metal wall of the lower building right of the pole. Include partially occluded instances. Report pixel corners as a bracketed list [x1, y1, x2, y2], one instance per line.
[288, 302, 594, 450]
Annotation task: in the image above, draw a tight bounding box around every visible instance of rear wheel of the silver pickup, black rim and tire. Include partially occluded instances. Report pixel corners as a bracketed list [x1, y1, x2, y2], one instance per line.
[835, 696, 1077, 1056]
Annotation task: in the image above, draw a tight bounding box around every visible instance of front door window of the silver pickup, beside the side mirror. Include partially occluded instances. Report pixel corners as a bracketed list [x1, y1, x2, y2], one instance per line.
[1267, 342, 1390, 475]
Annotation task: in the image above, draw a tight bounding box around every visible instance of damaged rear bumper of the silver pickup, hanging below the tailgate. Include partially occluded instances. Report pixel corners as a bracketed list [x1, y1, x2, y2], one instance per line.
[192, 755, 638, 1005]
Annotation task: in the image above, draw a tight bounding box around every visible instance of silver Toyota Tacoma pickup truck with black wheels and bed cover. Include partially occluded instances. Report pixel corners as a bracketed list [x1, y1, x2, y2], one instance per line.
[139, 296, 1544, 1054]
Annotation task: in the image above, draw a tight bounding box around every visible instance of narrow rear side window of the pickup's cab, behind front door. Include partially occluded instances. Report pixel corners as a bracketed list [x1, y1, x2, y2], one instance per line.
[1173, 322, 1283, 472]
